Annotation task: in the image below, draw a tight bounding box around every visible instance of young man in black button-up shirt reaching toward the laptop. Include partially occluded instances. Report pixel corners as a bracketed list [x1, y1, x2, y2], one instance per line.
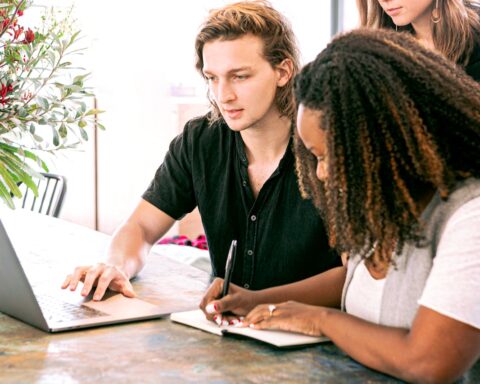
[63, 2, 339, 300]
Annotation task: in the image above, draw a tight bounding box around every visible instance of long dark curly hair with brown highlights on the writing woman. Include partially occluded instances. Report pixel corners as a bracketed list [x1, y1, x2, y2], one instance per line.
[295, 29, 480, 263]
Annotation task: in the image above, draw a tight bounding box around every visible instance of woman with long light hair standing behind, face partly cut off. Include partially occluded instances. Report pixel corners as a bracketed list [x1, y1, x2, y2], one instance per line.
[357, 0, 480, 81]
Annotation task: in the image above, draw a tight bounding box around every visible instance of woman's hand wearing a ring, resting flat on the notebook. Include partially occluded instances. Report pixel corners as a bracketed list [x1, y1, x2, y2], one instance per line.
[243, 301, 328, 336]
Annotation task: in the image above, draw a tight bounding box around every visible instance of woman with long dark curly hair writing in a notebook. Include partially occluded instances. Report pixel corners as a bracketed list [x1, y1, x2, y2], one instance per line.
[202, 30, 480, 382]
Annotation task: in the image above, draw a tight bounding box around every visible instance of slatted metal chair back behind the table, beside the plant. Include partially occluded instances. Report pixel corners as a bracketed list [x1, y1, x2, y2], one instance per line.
[20, 172, 67, 217]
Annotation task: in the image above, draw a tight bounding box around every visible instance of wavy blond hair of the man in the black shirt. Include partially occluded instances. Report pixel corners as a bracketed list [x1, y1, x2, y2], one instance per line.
[195, 1, 300, 121]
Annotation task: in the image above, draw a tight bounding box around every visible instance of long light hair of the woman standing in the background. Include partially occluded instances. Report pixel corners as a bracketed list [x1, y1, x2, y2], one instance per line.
[357, 0, 480, 66]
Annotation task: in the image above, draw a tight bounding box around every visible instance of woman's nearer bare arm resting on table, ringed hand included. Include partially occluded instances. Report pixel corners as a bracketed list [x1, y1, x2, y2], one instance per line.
[244, 302, 480, 383]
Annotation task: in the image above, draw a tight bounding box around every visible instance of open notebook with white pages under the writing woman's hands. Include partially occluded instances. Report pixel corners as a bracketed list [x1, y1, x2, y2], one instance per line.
[170, 309, 330, 348]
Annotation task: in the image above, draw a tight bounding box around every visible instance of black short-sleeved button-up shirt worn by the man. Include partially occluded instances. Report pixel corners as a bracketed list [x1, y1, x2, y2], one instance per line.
[143, 117, 340, 290]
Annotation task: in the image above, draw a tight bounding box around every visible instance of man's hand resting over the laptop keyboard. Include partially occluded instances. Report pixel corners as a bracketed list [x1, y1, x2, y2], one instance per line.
[62, 263, 135, 301]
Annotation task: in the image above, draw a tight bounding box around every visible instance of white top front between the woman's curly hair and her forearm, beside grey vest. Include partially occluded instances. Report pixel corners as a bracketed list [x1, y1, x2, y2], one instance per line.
[345, 260, 386, 324]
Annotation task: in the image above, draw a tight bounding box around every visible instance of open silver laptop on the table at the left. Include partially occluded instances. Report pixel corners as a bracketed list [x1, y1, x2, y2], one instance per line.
[0, 220, 182, 332]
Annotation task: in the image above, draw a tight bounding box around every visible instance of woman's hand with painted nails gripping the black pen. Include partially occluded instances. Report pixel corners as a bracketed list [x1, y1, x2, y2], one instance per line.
[199, 278, 258, 324]
